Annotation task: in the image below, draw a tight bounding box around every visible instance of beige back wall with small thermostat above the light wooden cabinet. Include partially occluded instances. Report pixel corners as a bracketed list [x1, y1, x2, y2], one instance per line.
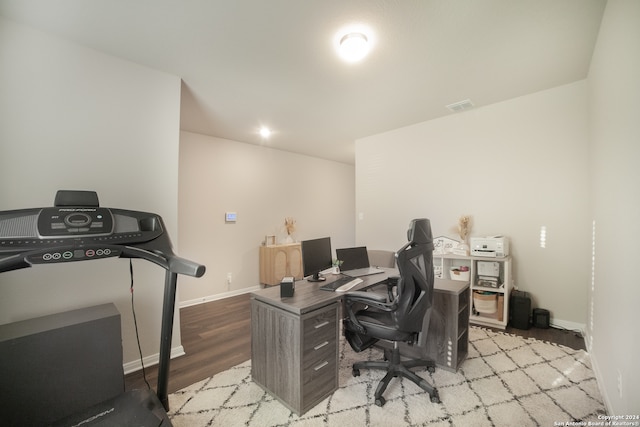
[179, 132, 355, 305]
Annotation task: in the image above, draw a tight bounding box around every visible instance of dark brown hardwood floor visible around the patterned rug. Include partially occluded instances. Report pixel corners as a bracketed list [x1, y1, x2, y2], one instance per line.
[125, 294, 585, 393]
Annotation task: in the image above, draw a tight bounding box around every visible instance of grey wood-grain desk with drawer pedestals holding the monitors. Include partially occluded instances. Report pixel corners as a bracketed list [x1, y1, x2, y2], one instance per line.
[251, 269, 469, 415]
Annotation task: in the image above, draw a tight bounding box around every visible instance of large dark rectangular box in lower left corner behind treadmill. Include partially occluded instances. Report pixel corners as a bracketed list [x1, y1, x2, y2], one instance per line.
[0, 303, 124, 427]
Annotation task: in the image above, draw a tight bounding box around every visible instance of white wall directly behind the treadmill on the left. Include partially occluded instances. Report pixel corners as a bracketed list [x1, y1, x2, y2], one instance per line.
[0, 17, 180, 372]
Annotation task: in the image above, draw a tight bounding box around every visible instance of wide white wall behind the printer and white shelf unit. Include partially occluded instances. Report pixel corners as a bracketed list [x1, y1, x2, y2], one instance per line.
[356, 81, 590, 327]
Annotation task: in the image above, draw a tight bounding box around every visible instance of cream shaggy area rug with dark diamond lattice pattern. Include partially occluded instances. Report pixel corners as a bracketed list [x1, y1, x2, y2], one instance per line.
[169, 327, 605, 427]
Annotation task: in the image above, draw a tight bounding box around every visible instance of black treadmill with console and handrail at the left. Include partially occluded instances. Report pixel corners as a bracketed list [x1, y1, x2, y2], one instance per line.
[0, 190, 205, 427]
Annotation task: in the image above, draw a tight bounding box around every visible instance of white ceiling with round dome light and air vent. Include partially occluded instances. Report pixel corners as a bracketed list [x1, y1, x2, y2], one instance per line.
[0, 0, 606, 164]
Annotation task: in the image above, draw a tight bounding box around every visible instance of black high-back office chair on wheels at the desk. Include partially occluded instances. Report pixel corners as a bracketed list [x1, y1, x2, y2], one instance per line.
[343, 219, 440, 406]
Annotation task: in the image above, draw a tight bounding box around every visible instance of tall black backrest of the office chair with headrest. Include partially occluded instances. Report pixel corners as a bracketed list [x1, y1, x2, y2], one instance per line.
[395, 218, 434, 332]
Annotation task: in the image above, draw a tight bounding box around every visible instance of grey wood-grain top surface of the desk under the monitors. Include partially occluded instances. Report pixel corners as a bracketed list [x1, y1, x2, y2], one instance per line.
[251, 268, 469, 314]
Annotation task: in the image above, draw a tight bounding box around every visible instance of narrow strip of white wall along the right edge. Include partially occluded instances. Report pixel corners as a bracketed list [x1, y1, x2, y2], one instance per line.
[587, 0, 640, 415]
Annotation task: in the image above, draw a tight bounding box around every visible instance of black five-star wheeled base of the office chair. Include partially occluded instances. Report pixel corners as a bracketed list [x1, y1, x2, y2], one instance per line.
[351, 342, 440, 406]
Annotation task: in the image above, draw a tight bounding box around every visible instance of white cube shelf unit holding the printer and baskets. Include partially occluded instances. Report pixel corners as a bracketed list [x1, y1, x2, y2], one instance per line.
[433, 254, 513, 329]
